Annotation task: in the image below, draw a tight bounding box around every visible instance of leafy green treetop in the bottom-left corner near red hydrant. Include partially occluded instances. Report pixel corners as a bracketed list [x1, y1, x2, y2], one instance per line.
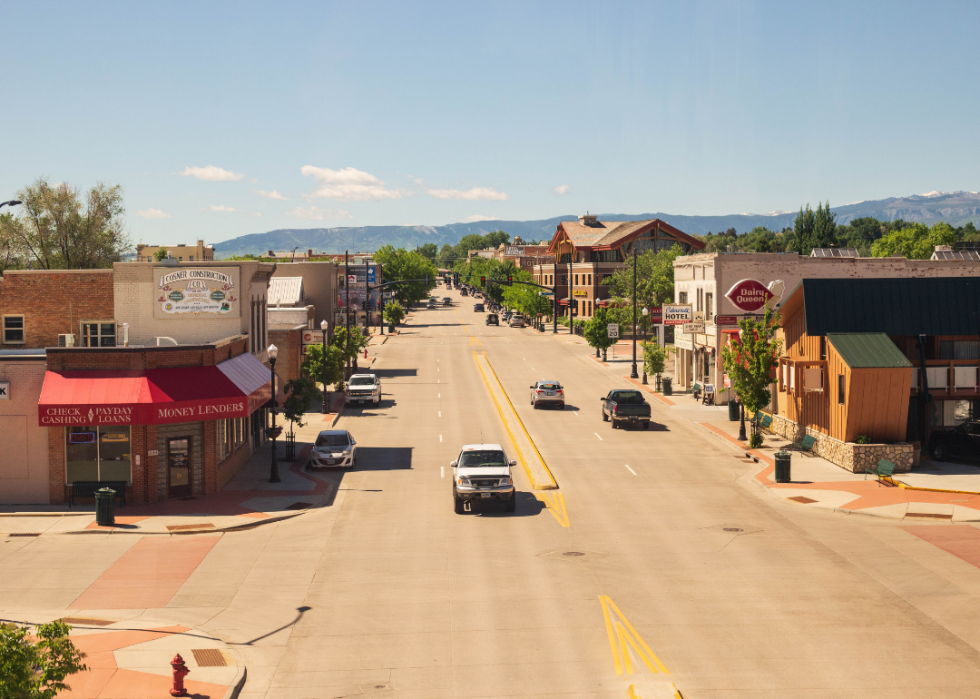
[0, 619, 88, 699]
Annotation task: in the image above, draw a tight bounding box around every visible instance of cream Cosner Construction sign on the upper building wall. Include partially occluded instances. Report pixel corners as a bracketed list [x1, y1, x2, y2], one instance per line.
[153, 267, 240, 318]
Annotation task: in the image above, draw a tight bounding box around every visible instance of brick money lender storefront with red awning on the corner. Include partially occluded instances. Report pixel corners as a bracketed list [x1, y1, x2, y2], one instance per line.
[38, 346, 271, 504]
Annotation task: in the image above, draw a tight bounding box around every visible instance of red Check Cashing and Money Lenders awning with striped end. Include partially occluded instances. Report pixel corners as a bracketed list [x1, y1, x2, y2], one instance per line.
[38, 354, 272, 427]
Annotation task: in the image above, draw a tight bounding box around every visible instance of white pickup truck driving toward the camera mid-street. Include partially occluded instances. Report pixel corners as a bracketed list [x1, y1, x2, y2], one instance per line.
[449, 444, 517, 515]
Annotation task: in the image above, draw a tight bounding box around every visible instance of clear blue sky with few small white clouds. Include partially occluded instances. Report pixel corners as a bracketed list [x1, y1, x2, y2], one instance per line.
[0, 0, 980, 244]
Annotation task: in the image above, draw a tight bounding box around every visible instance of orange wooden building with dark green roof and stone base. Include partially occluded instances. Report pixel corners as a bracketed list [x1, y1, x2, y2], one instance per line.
[772, 277, 980, 472]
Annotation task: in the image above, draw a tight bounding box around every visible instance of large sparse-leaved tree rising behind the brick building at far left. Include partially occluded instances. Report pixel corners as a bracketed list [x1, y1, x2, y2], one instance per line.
[0, 178, 131, 269]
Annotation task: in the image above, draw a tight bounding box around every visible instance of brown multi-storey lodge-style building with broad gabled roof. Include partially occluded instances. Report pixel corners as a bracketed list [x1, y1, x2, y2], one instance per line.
[532, 215, 704, 320]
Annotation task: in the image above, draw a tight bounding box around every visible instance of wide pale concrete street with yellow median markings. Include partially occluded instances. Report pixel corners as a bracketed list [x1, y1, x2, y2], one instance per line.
[0, 289, 980, 699]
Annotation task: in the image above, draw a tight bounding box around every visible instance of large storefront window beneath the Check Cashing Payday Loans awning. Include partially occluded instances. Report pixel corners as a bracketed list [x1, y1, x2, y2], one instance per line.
[65, 426, 133, 483]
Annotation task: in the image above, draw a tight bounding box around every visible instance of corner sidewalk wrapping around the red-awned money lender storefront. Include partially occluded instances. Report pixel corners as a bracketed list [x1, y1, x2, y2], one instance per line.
[0, 394, 343, 535]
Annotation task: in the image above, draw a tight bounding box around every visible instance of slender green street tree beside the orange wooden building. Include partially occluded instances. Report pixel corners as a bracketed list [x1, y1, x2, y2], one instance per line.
[721, 304, 783, 449]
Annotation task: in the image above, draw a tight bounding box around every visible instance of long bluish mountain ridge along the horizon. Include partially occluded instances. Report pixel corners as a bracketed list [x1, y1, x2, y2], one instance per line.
[214, 192, 980, 258]
